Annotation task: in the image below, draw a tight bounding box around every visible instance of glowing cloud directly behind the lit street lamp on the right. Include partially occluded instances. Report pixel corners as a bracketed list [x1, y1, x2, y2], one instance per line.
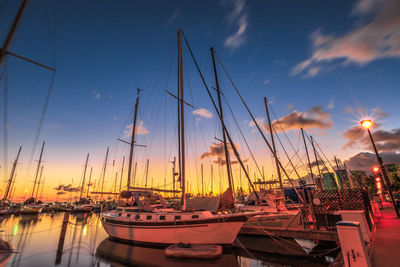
[343, 123, 400, 152]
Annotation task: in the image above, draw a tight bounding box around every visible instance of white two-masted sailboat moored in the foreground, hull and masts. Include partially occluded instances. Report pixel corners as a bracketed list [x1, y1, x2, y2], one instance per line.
[102, 30, 255, 245]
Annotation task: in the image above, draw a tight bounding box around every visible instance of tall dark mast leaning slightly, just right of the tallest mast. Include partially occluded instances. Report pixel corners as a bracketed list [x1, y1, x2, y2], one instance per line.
[210, 47, 234, 199]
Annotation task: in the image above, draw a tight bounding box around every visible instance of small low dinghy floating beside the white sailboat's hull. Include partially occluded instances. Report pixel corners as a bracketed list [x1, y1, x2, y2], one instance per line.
[165, 244, 222, 259]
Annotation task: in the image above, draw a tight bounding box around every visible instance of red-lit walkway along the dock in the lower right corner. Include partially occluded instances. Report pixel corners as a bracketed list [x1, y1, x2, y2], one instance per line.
[371, 208, 400, 267]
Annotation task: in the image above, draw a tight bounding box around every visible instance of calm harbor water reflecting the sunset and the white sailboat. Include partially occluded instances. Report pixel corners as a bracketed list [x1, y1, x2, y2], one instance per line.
[0, 213, 330, 267]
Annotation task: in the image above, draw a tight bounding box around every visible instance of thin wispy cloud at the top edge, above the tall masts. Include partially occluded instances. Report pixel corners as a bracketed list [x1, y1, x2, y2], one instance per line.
[224, 0, 248, 50]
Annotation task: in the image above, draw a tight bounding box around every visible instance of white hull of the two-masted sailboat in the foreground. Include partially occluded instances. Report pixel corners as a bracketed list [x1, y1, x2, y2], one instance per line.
[102, 211, 247, 245]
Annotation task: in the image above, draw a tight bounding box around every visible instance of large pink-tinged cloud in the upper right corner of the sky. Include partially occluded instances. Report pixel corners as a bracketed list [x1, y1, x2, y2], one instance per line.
[291, 0, 400, 77]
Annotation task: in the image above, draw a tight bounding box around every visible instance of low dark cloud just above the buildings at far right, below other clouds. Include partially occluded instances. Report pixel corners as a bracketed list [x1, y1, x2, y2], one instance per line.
[345, 152, 400, 171]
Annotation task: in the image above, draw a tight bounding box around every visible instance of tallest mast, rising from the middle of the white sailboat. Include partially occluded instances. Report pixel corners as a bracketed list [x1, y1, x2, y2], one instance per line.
[178, 30, 186, 210]
